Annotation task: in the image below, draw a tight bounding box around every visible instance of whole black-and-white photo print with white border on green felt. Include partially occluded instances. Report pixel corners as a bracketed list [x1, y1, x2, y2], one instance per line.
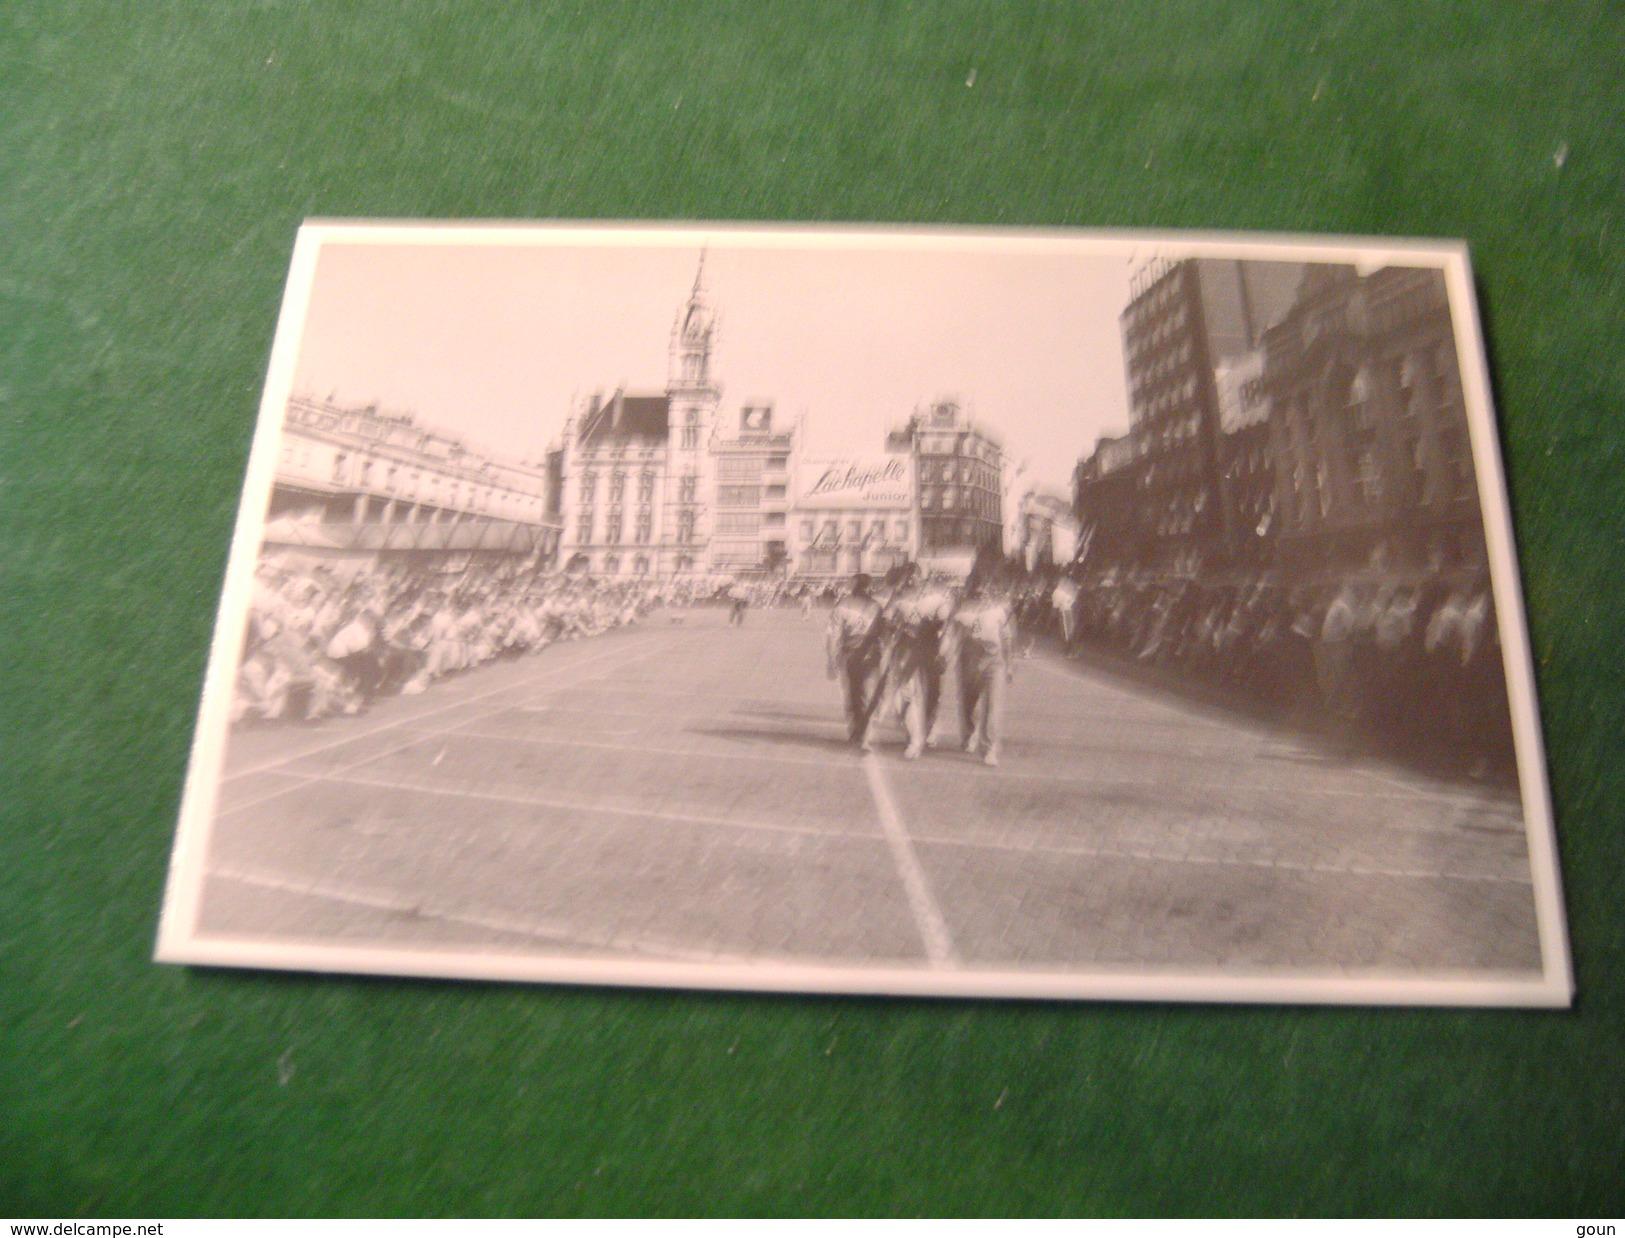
[158, 221, 1573, 1006]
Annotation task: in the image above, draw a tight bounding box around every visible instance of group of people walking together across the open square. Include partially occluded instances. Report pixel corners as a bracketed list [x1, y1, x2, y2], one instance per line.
[826, 564, 1016, 765]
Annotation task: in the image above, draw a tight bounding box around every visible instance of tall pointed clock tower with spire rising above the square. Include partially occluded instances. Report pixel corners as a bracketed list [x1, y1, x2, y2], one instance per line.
[665, 252, 722, 574]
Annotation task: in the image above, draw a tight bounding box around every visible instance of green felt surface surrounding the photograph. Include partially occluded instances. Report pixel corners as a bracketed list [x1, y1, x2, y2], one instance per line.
[0, 0, 1625, 1219]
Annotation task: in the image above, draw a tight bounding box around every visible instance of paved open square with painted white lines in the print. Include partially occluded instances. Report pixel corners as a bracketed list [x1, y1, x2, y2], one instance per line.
[198, 609, 1541, 975]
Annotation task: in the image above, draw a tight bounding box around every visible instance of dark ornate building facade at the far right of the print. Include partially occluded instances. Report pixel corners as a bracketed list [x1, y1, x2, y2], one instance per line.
[1263, 266, 1485, 572]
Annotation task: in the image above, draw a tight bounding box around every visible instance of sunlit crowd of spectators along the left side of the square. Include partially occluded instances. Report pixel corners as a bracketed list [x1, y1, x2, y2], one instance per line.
[231, 559, 689, 721]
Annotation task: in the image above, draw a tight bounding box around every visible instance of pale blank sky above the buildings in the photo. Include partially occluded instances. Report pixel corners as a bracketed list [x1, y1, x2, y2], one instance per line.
[294, 237, 1129, 492]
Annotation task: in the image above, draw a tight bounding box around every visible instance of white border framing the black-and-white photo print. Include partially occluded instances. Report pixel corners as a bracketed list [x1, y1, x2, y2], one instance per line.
[154, 219, 1575, 1007]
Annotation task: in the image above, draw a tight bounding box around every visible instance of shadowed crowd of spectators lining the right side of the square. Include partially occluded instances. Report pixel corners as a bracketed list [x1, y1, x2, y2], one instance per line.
[1019, 572, 1513, 777]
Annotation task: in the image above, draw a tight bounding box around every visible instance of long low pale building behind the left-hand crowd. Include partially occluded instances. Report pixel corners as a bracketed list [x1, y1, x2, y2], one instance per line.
[263, 396, 559, 569]
